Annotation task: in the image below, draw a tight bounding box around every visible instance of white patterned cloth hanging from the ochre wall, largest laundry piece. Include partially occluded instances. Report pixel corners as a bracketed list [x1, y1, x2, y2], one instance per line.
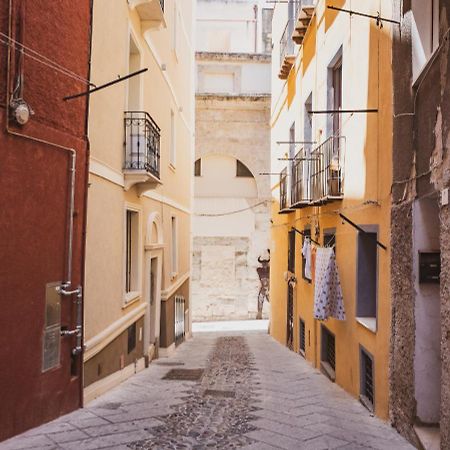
[314, 247, 345, 320]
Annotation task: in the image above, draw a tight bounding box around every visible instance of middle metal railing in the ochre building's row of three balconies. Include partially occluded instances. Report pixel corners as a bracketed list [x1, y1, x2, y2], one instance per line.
[291, 148, 311, 206]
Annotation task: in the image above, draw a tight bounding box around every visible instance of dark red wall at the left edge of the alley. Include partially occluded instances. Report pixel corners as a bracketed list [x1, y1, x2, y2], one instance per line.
[0, 0, 91, 441]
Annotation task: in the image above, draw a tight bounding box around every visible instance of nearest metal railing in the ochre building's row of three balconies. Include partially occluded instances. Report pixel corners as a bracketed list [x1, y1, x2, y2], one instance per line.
[311, 136, 345, 203]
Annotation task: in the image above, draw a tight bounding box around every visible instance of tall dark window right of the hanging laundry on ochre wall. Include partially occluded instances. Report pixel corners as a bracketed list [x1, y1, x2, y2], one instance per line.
[356, 231, 378, 330]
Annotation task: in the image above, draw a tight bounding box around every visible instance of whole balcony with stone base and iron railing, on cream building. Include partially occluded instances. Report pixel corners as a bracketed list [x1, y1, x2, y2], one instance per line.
[123, 111, 161, 194]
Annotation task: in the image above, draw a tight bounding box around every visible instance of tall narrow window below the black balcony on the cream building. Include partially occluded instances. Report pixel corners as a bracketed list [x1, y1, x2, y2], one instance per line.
[125, 209, 139, 293]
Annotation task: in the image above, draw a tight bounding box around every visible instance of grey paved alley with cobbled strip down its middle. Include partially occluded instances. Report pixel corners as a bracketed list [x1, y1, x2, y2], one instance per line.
[0, 331, 413, 450]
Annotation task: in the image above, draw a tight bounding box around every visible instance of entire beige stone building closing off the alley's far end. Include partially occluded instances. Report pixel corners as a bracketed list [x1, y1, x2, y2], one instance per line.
[192, 1, 272, 321]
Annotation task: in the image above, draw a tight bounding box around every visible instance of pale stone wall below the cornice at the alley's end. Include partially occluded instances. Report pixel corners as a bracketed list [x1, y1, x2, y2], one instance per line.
[191, 95, 271, 321]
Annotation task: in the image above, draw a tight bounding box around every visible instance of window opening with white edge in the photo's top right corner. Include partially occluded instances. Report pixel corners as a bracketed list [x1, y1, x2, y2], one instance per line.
[411, 0, 439, 81]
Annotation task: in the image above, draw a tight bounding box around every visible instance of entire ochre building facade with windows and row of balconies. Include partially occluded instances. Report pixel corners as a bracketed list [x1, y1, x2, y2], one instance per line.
[270, 0, 393, 419]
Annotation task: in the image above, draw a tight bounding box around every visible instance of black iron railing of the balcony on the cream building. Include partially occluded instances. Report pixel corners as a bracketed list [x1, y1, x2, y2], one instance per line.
[124, 111, 161, 178]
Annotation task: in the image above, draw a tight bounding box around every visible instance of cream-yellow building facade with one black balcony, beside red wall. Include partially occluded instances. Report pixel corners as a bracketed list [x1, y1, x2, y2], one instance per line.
[84, 0, 195, 401]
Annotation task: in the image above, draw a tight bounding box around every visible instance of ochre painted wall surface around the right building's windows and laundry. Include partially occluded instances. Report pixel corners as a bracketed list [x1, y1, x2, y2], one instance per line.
[270, 0, 392, 419]
